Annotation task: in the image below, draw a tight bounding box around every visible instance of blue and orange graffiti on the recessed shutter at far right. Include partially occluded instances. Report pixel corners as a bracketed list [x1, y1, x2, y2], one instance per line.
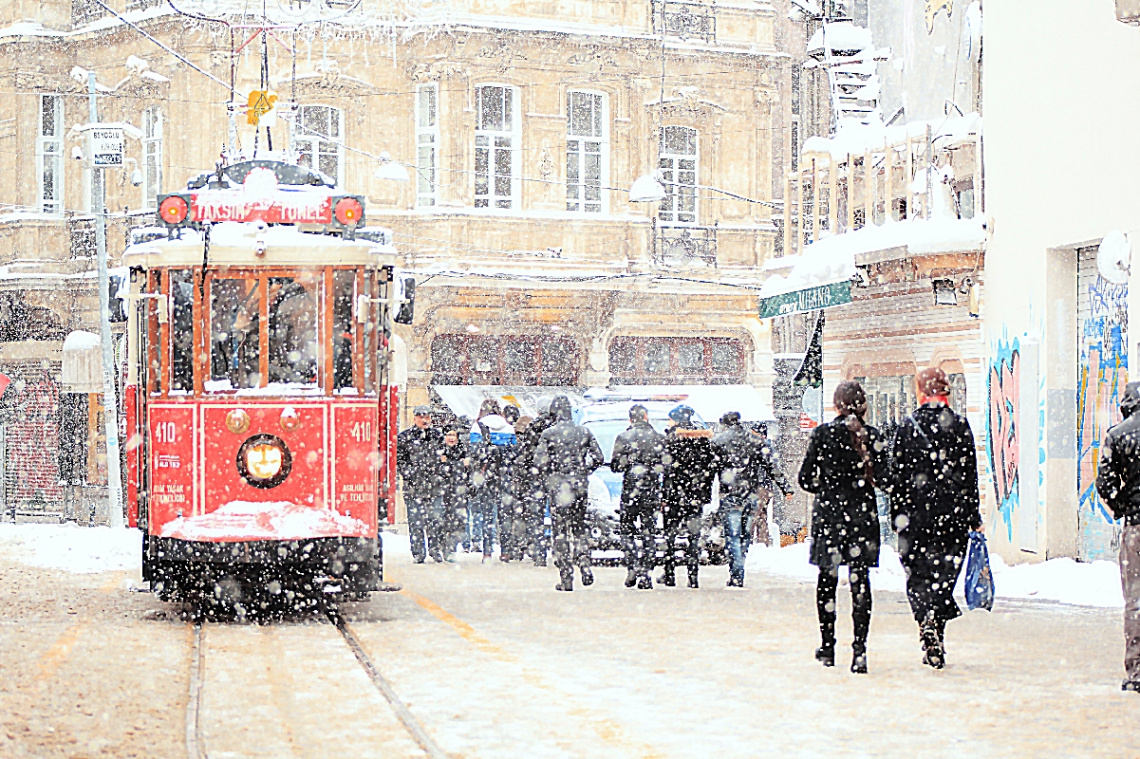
[1076, 276, 1129, 558]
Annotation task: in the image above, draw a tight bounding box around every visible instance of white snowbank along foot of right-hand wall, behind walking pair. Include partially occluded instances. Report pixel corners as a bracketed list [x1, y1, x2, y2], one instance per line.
[747, 544, 1124, 607]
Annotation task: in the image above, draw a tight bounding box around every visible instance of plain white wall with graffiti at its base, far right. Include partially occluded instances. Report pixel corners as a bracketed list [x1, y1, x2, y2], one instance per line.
[984, 0, 1140, 561]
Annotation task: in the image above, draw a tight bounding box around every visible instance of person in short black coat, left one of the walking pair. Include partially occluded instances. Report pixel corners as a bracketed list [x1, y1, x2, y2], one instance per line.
[799, 382, 889, 674]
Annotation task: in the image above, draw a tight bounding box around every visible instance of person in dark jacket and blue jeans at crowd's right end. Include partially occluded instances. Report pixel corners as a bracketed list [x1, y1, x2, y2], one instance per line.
[713, 411, 791, 588]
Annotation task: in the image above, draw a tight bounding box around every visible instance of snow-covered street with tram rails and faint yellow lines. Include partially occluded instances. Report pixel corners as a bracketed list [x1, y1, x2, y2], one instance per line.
[0, 525, 1140, 758]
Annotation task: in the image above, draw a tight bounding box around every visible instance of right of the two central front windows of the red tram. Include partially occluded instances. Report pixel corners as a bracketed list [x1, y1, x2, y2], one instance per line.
[269, 277, 318, 385]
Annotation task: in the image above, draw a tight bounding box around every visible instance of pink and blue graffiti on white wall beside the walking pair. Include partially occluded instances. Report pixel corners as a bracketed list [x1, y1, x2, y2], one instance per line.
[986, 340, 1021, 539]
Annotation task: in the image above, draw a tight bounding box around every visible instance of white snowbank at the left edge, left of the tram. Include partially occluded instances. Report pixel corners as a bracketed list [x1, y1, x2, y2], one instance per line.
[0, 523, 143, 574]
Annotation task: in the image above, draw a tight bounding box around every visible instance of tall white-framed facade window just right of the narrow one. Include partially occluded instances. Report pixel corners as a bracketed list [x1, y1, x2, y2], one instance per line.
[475, 85, 516, 210]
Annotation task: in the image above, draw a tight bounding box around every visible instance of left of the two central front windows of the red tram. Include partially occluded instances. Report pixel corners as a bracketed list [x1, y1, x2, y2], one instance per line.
[206, 277, 261, 391]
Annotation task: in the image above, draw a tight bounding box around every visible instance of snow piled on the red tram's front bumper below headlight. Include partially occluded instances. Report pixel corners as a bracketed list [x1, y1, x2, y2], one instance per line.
[158, 500, 368, 541]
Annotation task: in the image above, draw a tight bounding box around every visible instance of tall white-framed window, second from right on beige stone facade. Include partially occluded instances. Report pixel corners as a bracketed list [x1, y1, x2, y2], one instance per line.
[567, 92, 609, 213]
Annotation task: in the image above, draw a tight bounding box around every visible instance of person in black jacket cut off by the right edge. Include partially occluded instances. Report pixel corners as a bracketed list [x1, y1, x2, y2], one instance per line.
[1097, 382, 1140, 693]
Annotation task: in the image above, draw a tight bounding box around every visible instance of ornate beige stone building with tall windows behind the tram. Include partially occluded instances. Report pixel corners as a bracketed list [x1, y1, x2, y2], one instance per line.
[0, 0, 791, 508]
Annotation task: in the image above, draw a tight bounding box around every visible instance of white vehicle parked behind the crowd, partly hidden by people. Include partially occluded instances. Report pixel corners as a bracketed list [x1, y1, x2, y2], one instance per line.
[573, 393, 725, 564]
